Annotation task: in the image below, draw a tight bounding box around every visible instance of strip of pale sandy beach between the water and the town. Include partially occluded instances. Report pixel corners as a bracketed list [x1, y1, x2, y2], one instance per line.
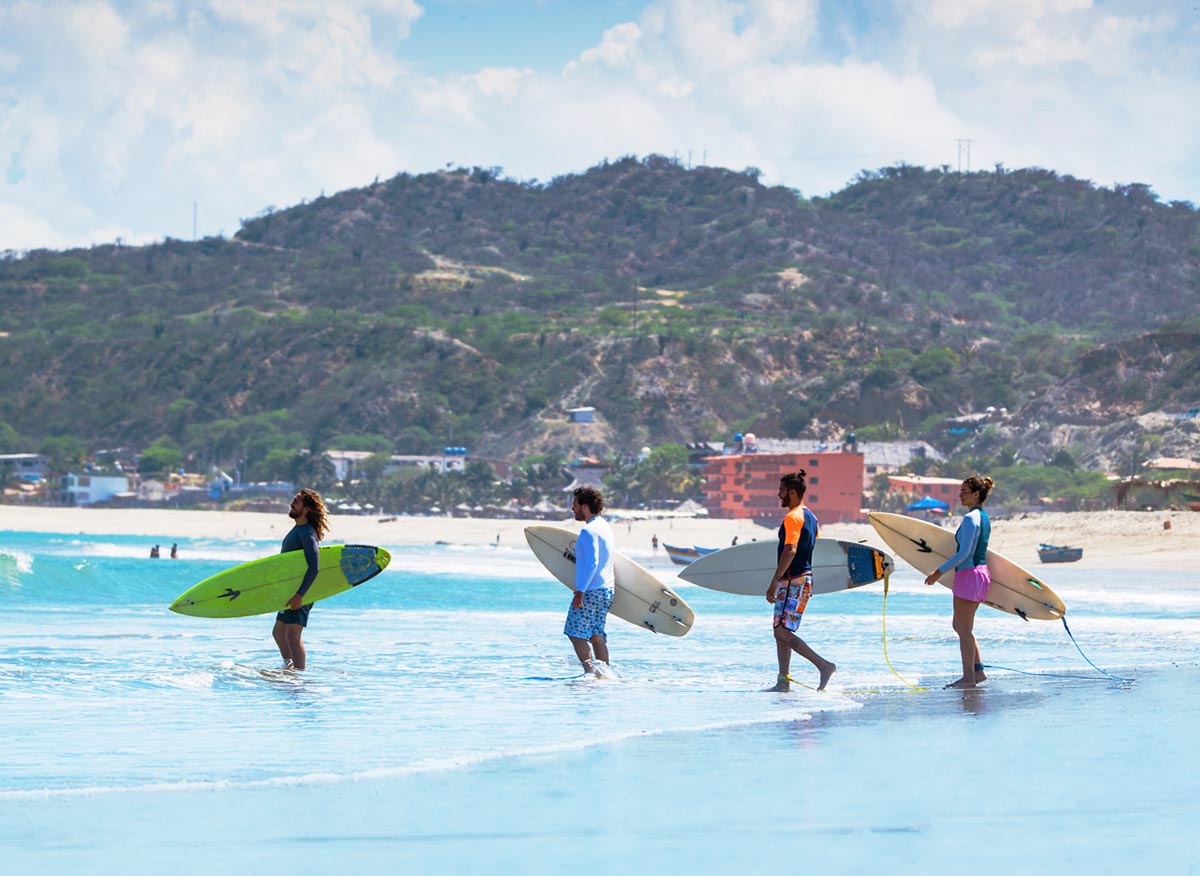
[0, 505, 1200, 571]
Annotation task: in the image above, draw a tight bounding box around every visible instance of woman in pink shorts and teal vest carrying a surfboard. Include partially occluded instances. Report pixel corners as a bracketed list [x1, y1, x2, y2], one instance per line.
[925, 475, 994, 688]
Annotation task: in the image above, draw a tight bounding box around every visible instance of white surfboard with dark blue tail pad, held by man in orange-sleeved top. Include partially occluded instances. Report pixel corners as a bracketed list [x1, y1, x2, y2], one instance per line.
[679, 539, 893, 596]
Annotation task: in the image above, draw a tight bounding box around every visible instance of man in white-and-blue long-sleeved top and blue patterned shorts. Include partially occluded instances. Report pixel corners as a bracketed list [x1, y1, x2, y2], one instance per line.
[563, 487, 616, 676]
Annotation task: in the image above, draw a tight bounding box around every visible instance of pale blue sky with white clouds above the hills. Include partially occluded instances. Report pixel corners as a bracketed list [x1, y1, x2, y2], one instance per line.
[0, 0, 1200, 251]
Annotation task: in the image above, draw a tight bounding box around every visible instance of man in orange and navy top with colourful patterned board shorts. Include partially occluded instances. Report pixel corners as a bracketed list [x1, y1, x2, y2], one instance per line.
[767, 468, 838, 692]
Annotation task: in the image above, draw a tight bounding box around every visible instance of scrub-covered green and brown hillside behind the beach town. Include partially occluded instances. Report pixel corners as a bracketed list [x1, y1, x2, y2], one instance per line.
[0, 156, 1200, 476]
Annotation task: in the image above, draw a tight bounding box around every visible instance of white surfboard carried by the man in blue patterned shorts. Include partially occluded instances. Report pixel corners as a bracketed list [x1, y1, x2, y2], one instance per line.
[526, 526, 696, 636]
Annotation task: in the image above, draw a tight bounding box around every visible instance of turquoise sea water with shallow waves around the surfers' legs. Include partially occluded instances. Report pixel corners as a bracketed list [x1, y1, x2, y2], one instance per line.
[0, 533, 1200, 874]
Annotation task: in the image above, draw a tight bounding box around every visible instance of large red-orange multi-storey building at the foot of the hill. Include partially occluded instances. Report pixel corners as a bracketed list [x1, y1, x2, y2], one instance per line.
[703, 452, 865, 523]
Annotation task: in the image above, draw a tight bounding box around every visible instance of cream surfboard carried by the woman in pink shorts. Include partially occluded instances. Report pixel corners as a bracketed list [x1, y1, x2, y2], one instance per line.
[870, 511, 1067, 620]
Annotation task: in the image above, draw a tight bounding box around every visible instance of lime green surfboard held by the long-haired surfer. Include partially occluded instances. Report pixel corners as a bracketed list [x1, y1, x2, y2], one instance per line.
[170, 545, 391, 618]
